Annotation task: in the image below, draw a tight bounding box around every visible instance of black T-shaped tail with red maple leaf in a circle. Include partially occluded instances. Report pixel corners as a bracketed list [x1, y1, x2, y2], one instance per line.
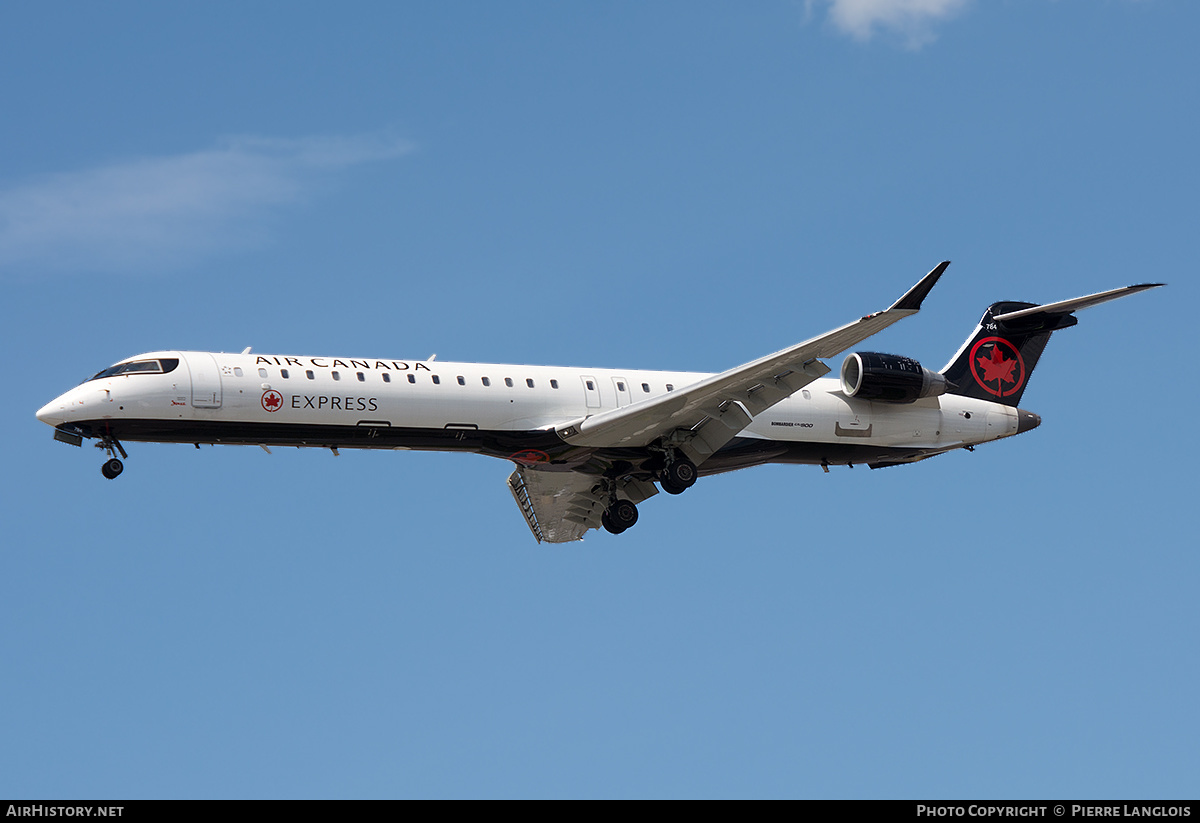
[942, 283, 1163, 406]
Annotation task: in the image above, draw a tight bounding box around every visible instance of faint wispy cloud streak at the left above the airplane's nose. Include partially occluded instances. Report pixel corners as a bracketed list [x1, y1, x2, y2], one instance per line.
[0, 134, 410, 274]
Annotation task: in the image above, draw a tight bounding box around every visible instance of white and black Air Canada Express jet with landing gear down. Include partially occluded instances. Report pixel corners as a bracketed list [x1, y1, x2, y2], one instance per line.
[37, 260, 1163, 543]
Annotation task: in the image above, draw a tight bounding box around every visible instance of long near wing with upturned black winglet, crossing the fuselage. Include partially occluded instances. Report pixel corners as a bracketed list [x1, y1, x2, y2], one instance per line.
[556, 260, 950, 464]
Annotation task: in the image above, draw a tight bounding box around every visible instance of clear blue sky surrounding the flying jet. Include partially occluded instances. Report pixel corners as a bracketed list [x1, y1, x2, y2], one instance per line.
[0, 0, 1200, 798]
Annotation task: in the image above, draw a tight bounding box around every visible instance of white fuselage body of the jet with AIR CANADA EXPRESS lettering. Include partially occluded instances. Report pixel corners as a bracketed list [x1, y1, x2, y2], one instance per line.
[37, 352, 1018, 463]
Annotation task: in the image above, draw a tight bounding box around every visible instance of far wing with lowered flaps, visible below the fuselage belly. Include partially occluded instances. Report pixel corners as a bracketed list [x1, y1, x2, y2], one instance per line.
[509, 467, 658, 543]
